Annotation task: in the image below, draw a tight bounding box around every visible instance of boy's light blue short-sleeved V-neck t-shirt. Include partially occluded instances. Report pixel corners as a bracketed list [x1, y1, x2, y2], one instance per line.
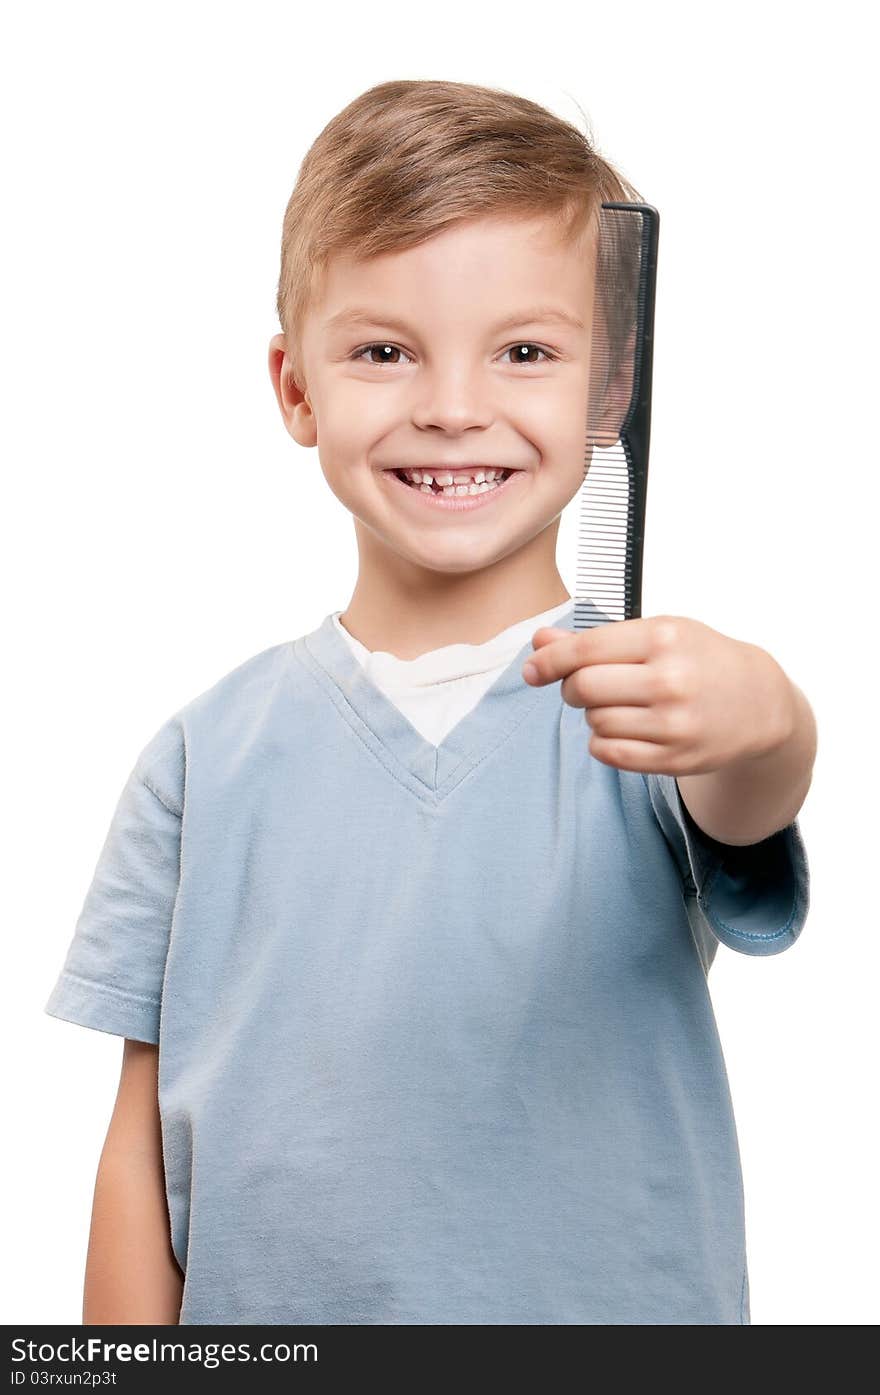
[46, 604, 809, 1325]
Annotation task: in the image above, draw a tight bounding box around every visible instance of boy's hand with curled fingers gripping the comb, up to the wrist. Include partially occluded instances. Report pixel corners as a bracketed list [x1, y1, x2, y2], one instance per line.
[523, 615, 796, 776]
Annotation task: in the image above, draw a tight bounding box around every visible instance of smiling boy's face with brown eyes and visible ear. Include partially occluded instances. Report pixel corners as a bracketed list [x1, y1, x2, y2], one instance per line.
[269, 216, 613, 573]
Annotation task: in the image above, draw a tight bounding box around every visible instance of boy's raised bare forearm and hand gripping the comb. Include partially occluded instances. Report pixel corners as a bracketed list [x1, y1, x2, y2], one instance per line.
[523, 615, 817, 847]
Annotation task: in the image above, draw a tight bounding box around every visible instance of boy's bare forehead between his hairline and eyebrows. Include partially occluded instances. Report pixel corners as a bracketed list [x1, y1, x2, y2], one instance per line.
[310, 215, 595, 332]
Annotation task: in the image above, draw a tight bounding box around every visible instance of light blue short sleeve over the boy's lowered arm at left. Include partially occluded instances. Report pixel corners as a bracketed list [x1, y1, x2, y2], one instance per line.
[43, 718, 184, 1043]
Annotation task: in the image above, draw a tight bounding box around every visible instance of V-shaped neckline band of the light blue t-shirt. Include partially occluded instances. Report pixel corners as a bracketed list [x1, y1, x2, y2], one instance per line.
[291, 600, 575, 802]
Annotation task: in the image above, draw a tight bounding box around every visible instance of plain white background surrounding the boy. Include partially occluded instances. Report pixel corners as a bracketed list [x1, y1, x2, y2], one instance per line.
[0, 0, 880, 1325]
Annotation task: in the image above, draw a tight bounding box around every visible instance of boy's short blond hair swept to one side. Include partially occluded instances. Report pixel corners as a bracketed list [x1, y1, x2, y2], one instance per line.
[276, 80, 642, 385]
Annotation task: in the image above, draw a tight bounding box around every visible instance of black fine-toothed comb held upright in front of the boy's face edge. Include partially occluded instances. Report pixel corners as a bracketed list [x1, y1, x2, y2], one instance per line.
[573, 204, 660, 629]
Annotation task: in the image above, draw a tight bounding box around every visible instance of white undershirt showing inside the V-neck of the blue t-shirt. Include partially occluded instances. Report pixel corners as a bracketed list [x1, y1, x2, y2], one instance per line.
[332, 600, 573, 746]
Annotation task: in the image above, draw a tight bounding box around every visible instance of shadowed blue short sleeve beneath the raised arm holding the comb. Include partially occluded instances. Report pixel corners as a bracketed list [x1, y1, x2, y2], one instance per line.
[643, 774, 810, 963]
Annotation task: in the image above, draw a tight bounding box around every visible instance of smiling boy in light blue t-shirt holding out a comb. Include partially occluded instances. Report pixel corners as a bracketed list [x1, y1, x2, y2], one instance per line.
[47, 82, 816, 1325]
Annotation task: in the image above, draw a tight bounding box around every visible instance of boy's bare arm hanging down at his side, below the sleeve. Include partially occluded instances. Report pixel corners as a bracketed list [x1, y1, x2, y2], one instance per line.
[82, 1038, 183, 1325]
